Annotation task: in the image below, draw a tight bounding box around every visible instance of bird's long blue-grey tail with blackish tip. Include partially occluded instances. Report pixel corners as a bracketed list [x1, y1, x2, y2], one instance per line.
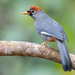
[57, 40, 72, 71]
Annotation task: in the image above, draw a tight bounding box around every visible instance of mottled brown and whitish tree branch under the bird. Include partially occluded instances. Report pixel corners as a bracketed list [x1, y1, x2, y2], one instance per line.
[0, 41, 75, 70]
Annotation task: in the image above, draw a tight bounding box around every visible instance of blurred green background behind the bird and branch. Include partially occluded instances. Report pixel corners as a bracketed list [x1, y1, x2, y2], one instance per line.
[0, 0, 75, 75]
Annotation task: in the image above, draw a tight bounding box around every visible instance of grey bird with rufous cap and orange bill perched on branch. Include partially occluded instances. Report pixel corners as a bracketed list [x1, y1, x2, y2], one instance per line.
[22, 6, 72, 72]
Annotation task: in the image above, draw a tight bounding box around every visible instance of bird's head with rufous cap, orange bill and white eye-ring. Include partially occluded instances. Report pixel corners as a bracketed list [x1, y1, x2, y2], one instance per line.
[22, 6, 44, 19]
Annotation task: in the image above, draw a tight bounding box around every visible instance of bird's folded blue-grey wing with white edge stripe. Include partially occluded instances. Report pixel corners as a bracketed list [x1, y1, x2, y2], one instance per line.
[38, 18, 68, 41]
